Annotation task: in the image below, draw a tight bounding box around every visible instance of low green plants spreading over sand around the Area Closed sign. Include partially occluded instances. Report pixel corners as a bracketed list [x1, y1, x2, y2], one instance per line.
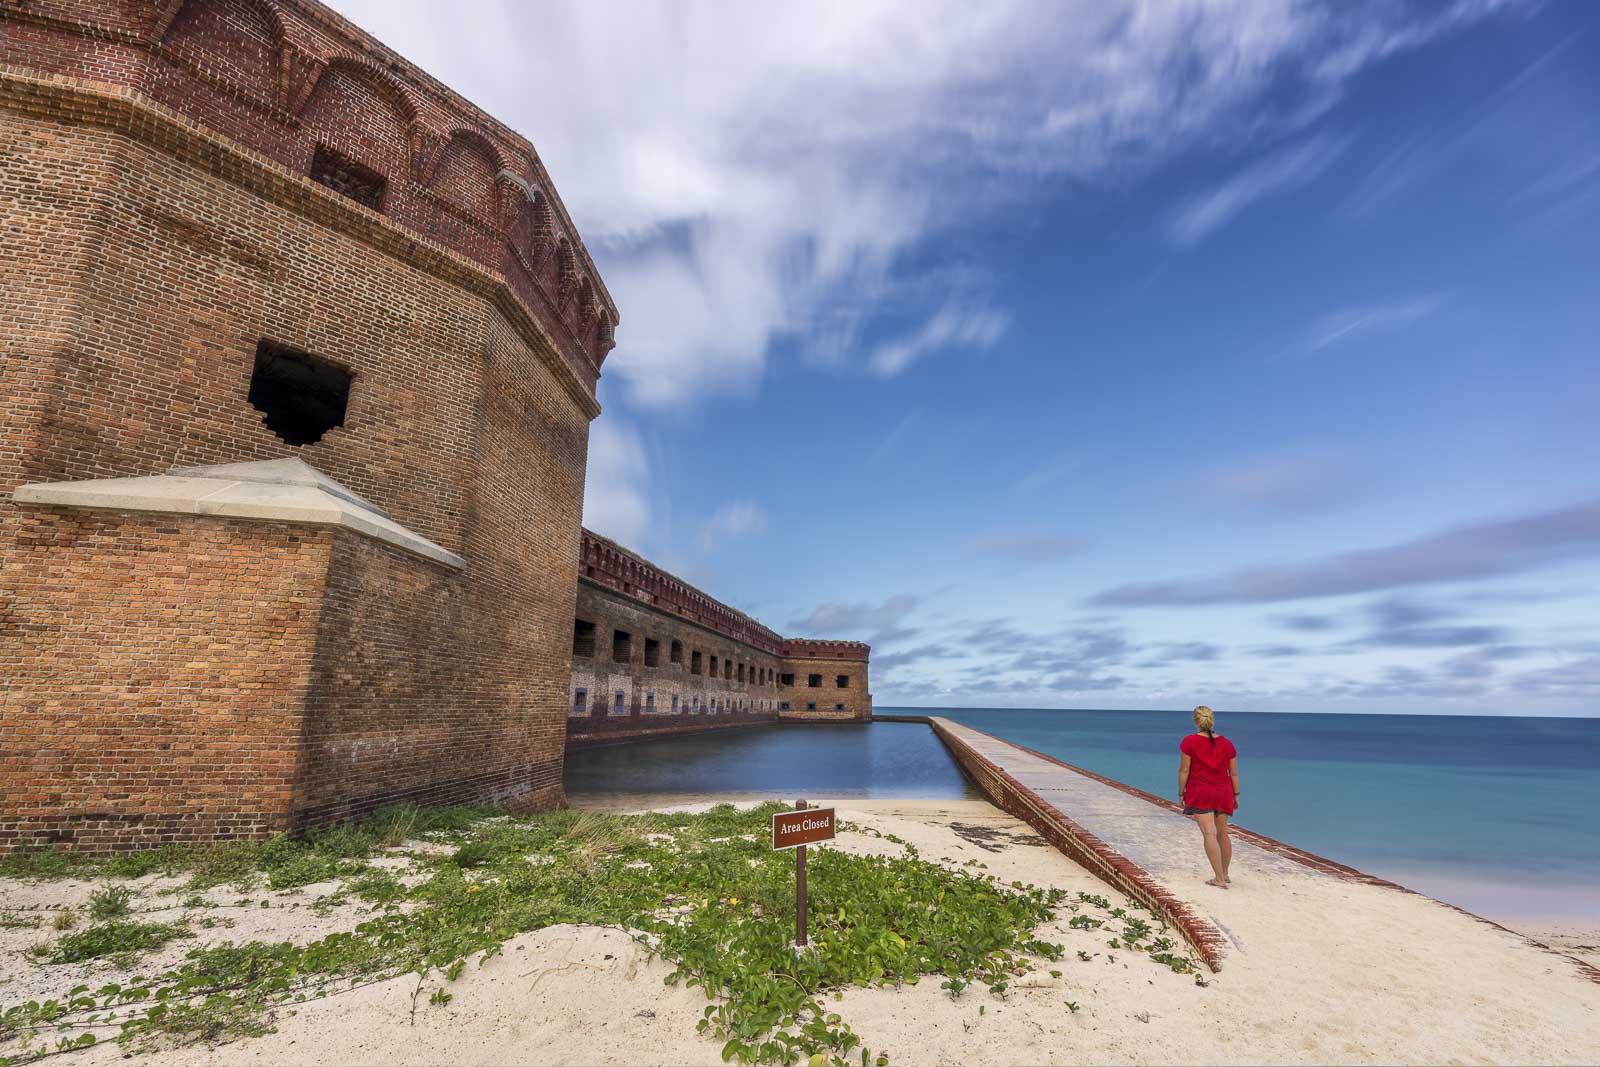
[0, 805, 1192, 1067]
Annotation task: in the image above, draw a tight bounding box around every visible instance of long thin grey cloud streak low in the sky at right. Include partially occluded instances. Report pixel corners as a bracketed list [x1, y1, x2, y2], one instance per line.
[1090, 499, 1600, 606]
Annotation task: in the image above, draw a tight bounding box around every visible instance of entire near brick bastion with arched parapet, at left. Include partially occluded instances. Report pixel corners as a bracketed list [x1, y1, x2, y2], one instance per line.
[0, 0, 604, 851]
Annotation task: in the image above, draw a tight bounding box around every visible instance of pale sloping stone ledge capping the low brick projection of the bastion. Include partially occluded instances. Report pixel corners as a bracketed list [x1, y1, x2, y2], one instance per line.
[11, 459, 467, 569]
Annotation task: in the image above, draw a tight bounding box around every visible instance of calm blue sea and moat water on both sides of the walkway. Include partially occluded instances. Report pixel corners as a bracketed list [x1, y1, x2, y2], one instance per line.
[566, 707, 1600, 923]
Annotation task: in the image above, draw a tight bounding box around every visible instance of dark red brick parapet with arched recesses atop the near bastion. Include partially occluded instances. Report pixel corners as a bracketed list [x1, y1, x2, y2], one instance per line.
[0, 0, 619, 392]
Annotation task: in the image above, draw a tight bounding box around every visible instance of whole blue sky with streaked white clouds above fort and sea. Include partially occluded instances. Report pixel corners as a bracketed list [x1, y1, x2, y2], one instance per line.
[336, 0, 1600, 715]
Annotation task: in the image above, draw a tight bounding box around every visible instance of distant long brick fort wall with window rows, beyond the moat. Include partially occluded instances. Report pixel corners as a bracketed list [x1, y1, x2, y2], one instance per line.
[566, 531, 872, 747]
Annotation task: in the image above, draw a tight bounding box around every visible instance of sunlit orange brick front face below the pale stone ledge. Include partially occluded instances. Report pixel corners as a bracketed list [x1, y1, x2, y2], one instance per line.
[0, 507, 331, 851]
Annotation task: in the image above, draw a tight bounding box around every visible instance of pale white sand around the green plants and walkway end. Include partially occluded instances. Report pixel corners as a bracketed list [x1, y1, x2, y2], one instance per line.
[0, 801, 1600, 1065]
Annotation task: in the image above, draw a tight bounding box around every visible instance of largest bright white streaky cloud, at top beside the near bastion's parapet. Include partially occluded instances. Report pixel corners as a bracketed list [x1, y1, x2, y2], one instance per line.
[334, 0, 1504, 408]
